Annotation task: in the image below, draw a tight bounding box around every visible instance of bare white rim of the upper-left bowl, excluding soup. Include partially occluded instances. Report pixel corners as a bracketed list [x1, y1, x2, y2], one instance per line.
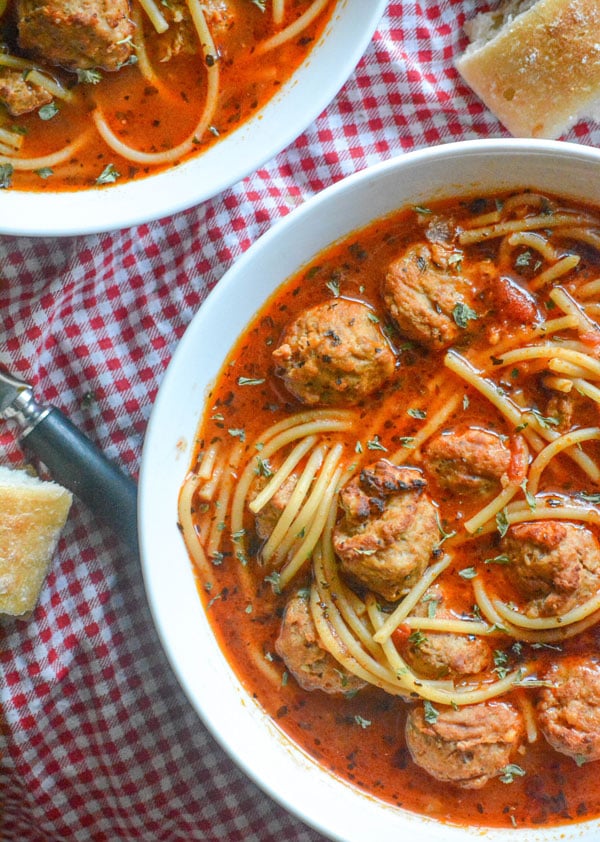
[0, 0, 387, 237]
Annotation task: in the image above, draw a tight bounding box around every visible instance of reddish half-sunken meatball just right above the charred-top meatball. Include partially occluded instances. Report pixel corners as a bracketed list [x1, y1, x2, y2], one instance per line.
[425, 427, 511, 494]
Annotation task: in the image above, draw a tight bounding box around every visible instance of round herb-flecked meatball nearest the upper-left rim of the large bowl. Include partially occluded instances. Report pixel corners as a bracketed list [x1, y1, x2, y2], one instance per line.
[273, 298, 395, 405]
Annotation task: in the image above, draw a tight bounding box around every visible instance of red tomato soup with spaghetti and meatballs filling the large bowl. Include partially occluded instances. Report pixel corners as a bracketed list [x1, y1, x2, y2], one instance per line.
[179, 190, 600, 827]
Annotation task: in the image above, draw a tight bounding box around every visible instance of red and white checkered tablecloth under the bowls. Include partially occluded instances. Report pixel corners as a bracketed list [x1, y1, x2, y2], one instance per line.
[0, 0, 600, 842]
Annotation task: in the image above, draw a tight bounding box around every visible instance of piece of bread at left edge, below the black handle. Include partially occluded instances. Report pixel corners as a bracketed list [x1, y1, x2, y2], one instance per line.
[0, 467, 73, 615]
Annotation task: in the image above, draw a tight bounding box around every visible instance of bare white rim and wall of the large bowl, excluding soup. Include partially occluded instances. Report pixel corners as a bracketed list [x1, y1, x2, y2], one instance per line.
[139, 140, 600, 842]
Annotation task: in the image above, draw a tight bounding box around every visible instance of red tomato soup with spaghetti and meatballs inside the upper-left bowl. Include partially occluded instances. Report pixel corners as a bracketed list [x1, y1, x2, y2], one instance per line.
[0, 0, 336, 191]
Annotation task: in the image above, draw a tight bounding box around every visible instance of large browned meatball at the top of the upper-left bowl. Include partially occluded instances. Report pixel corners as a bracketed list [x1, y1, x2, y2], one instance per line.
[17, 0, 133, 70]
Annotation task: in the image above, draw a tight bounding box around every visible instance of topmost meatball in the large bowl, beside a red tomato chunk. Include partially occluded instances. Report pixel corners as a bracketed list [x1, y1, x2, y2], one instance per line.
[383, 243, 472, 349]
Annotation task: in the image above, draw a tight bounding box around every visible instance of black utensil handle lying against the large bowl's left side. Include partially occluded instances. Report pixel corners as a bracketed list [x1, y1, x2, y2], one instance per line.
[20, 407, 138, 554]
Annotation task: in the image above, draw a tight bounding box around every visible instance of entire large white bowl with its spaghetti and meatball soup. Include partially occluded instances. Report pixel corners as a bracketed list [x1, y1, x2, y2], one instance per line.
[139, 140, 600, 842]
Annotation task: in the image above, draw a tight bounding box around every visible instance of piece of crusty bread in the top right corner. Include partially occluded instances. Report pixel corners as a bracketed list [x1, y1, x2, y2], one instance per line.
[456, 0, 600, 138]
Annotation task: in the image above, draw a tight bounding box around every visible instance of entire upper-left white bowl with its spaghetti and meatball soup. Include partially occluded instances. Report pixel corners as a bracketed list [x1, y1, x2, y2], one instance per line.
[0, 0, 385, 236]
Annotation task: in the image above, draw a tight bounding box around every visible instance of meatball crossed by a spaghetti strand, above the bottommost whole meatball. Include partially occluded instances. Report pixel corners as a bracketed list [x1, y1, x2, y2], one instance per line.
[399, 588, 492, 678]
